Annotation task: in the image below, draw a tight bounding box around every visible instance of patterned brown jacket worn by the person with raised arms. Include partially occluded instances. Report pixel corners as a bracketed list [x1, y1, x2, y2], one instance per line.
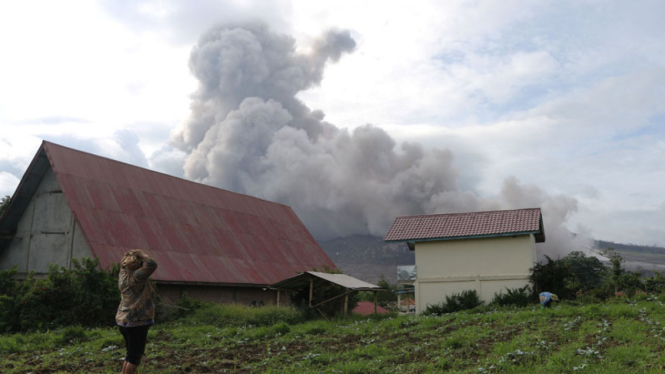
[115, 258, 157, 327]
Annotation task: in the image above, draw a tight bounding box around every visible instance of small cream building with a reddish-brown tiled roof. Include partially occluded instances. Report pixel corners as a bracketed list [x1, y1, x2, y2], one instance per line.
[384, 208, 545, 313]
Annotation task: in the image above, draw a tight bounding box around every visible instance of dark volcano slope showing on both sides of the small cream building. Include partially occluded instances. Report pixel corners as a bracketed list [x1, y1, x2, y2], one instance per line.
[319, 235, 665, 284]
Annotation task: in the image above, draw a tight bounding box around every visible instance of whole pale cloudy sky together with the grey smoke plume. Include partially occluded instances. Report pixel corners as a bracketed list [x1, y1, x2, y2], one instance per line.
[0, 0, 665, 250]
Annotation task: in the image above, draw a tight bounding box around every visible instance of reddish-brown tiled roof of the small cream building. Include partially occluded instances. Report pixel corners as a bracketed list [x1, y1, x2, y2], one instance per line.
[384, 208, 545, 243]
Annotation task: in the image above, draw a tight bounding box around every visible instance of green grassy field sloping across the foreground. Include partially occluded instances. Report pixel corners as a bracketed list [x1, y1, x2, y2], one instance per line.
[0, 296, 665, 374]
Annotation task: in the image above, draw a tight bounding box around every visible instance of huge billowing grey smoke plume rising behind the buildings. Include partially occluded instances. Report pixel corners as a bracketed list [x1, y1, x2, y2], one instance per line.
[172, 24, 588, 258]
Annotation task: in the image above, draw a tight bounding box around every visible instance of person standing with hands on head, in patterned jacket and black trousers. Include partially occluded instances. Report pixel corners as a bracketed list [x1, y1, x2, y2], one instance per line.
[115, 249, 157, 374]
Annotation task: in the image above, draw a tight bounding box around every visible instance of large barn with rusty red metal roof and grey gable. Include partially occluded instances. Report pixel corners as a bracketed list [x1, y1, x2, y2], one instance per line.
[0, 142, 335, 304]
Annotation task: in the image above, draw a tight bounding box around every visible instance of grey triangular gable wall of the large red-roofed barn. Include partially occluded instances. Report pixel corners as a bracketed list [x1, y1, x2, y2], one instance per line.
[0, 168, 92, 275]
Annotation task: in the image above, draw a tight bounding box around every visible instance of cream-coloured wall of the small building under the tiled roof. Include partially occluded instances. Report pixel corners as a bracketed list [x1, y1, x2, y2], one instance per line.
[414, 235, 536, 313]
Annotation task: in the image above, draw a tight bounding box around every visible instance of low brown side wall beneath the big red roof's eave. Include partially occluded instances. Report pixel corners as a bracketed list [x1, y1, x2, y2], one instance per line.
[156, 283, 278, 305]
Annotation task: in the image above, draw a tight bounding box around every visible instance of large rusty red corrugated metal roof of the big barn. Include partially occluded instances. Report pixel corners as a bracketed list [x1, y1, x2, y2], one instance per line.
[7, 142, 335, 285]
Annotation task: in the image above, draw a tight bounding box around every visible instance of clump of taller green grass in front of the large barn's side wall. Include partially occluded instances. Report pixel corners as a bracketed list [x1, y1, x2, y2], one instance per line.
[187, 304, 304, 327]
